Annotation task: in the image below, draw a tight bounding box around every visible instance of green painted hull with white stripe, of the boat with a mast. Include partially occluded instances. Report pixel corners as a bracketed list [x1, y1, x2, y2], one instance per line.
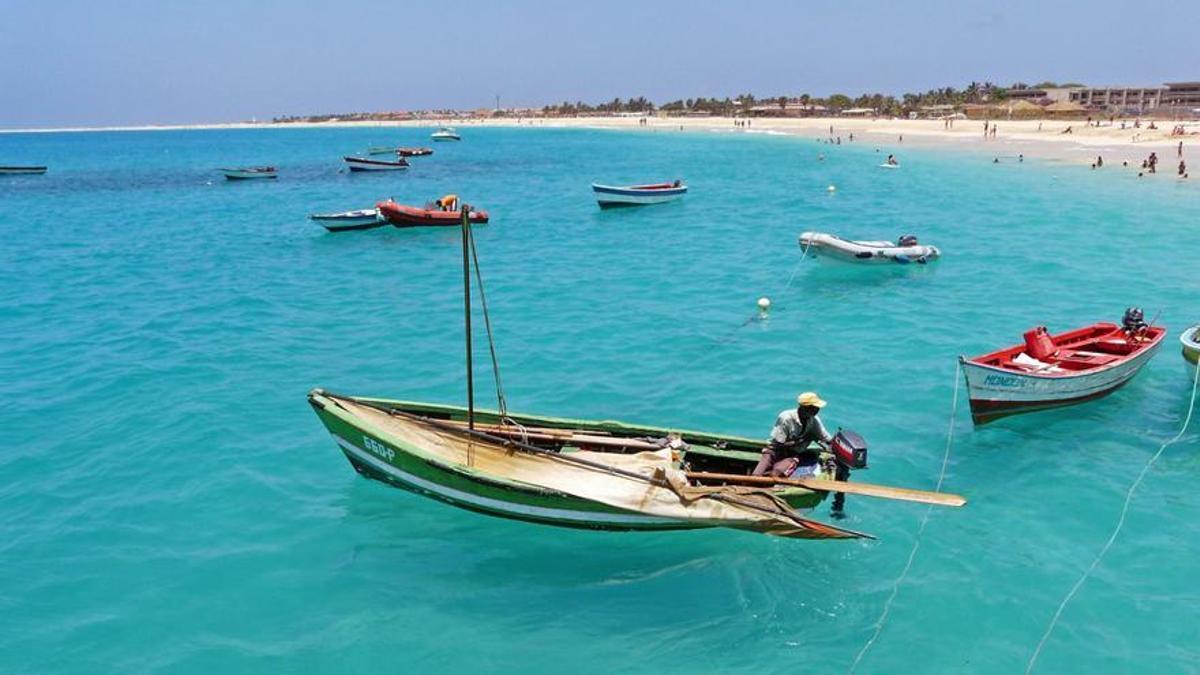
[308, 390, 827, 531]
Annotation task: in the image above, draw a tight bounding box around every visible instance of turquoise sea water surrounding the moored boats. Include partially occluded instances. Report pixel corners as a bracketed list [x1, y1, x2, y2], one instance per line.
[0, 129, 1200, 673]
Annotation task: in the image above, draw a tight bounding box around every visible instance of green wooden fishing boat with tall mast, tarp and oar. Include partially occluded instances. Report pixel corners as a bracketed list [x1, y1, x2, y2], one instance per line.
[308, 207, 965, 539]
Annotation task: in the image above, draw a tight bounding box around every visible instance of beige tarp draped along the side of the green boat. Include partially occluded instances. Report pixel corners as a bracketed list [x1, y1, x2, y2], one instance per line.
[336, 394, 864, 539]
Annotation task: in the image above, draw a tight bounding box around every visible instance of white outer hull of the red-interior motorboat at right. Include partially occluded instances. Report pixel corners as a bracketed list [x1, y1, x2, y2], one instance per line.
[962, 341, 1162, 424]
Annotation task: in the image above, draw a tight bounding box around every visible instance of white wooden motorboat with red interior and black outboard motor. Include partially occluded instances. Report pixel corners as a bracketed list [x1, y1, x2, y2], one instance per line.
[959, 309, 1166, 424]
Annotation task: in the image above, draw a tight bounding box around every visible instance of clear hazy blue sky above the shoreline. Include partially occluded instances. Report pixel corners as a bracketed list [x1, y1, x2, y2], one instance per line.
[0, 0, 1200, 127]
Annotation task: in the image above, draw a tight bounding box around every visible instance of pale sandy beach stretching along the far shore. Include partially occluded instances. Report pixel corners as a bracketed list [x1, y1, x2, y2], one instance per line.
[0, 117, 1200, 169]
